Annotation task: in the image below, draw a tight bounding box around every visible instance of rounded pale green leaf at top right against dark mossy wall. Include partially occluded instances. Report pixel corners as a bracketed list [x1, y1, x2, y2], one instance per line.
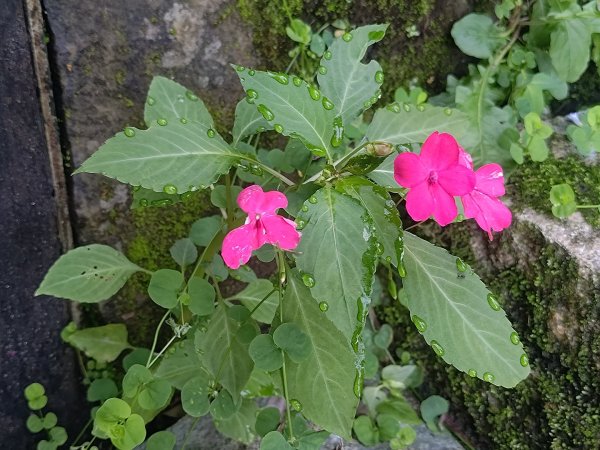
[451, 14, 506, 59]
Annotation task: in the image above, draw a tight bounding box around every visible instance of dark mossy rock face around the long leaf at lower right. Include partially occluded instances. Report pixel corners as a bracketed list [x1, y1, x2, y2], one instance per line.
[380, 223, 600, 450]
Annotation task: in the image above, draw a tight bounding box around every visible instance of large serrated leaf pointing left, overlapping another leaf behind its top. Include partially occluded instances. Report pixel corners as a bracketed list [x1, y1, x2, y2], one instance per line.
[75, 120, 238, 194]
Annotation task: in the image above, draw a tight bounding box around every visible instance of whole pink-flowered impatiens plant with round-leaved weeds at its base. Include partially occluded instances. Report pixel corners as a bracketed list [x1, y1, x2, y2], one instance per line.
[37, 25, 529, 449]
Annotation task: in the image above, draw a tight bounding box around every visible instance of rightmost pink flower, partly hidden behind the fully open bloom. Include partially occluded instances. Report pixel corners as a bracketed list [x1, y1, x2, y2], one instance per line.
[459, 148, 512, 241]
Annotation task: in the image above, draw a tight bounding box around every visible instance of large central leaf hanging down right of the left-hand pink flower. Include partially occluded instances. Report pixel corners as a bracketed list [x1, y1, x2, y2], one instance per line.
[296, 186, 377, 339]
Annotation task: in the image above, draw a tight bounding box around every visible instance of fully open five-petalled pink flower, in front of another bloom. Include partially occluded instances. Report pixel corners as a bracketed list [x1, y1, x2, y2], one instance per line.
[394, 131, 475, 226]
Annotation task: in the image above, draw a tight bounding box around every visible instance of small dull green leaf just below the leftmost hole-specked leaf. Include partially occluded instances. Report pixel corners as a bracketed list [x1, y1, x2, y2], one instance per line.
[69, 323, 132, 362]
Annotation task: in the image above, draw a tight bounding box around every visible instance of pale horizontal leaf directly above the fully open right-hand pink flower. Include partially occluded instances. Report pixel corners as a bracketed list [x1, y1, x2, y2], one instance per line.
[366, 103, 469, 144]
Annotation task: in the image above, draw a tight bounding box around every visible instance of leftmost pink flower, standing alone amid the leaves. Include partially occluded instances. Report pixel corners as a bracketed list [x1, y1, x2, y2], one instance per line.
[221, 185, 300, 269]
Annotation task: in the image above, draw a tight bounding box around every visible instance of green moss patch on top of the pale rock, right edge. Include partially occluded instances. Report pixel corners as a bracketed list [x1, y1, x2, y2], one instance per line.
[509, 155, 600, 228]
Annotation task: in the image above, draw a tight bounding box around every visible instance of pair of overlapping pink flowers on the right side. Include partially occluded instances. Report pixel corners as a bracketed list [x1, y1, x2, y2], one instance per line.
[394, 131, 512, 239]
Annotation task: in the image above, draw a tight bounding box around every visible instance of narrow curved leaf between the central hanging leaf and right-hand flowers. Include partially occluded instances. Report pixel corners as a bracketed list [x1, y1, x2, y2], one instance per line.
[341, 177, 402, 267]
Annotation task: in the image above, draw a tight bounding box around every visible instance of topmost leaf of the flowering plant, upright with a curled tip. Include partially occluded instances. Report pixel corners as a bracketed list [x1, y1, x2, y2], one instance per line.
[317, 25, 387, 124]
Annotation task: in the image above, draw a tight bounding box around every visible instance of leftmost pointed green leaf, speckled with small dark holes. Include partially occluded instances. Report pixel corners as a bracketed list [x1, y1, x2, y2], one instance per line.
[35, 244, 142, 303]
